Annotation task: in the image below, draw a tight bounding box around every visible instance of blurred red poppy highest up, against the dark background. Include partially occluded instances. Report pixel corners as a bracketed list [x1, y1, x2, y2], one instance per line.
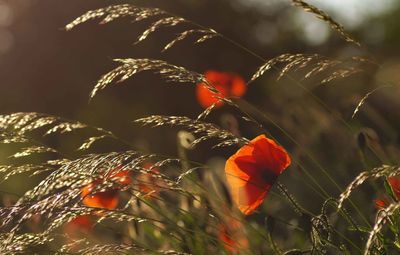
[196, 70, 247, 108]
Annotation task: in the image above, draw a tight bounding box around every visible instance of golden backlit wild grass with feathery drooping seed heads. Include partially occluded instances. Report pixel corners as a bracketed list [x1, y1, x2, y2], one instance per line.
[0, 0, 400, 255]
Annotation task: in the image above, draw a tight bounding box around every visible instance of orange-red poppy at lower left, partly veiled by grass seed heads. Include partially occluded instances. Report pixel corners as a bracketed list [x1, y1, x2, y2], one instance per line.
[81, 169, 132, 209]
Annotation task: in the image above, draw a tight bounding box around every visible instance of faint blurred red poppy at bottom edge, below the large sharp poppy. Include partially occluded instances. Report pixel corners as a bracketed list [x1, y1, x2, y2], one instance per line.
[218, 218, 248, 253]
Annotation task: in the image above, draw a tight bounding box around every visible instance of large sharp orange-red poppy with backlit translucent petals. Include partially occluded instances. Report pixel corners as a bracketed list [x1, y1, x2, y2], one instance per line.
[225, 135, 291, 215]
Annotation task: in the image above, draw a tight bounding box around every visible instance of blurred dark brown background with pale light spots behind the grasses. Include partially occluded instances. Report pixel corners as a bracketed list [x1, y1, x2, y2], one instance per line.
[0, 0, 400, 236]
